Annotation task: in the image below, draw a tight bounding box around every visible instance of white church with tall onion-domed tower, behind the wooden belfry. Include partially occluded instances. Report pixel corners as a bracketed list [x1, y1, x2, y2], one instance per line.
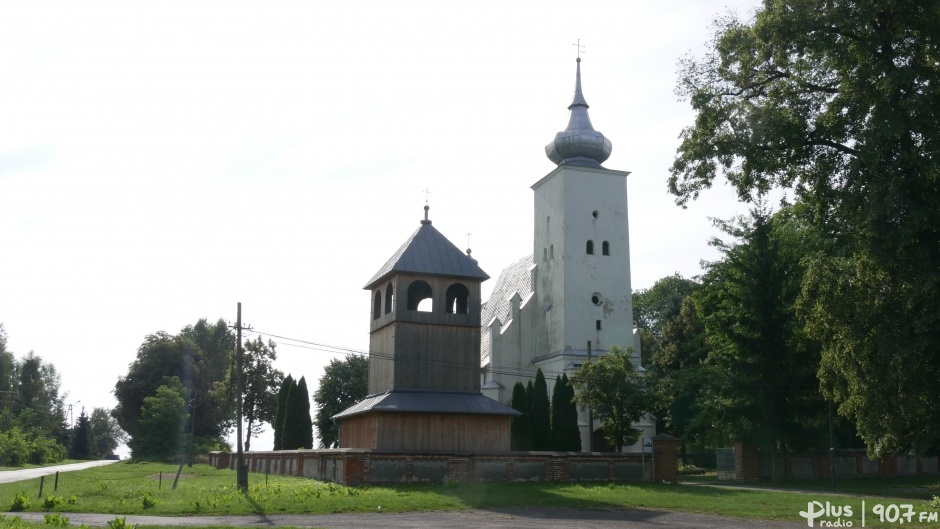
[481, 58, 654, 451]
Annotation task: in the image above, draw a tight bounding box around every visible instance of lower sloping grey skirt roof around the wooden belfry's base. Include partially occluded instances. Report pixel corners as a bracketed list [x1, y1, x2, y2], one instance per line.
[332, 391, 520, 419]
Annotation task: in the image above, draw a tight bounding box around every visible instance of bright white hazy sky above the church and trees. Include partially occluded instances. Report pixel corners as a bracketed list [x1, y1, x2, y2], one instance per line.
[0, 0, 758, 453]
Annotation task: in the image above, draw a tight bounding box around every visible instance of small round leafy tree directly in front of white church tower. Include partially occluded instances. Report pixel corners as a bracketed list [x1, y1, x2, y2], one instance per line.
[571, 346, 652, 452]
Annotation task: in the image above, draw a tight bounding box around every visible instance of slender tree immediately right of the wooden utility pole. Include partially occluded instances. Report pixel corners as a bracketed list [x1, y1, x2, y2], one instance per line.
[235, 336, 284, 451]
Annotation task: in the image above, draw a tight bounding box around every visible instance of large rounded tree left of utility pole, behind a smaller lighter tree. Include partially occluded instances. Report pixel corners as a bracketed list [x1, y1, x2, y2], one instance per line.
[112, 319, 235, 458]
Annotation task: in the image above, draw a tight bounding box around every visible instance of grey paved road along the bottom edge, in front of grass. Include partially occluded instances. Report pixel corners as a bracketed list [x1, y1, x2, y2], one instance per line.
[3, 508, 806, 529]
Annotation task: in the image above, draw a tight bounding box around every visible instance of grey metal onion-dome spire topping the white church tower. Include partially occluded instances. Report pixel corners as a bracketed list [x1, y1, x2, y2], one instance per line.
[545, 57, 613, 167]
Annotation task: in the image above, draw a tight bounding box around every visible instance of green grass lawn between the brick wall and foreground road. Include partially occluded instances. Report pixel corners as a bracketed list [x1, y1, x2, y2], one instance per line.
[0, 462, 940, 528]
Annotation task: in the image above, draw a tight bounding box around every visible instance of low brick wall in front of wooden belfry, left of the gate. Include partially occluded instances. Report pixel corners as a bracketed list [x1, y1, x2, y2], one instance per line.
[209, 438, 676, 485]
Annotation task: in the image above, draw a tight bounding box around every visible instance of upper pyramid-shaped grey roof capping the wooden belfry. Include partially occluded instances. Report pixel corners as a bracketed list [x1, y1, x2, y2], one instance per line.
[363, 206, 490, 290]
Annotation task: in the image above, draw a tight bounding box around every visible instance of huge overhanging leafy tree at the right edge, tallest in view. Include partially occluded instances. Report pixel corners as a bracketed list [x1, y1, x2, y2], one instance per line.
[669, 0, 940, 456]
